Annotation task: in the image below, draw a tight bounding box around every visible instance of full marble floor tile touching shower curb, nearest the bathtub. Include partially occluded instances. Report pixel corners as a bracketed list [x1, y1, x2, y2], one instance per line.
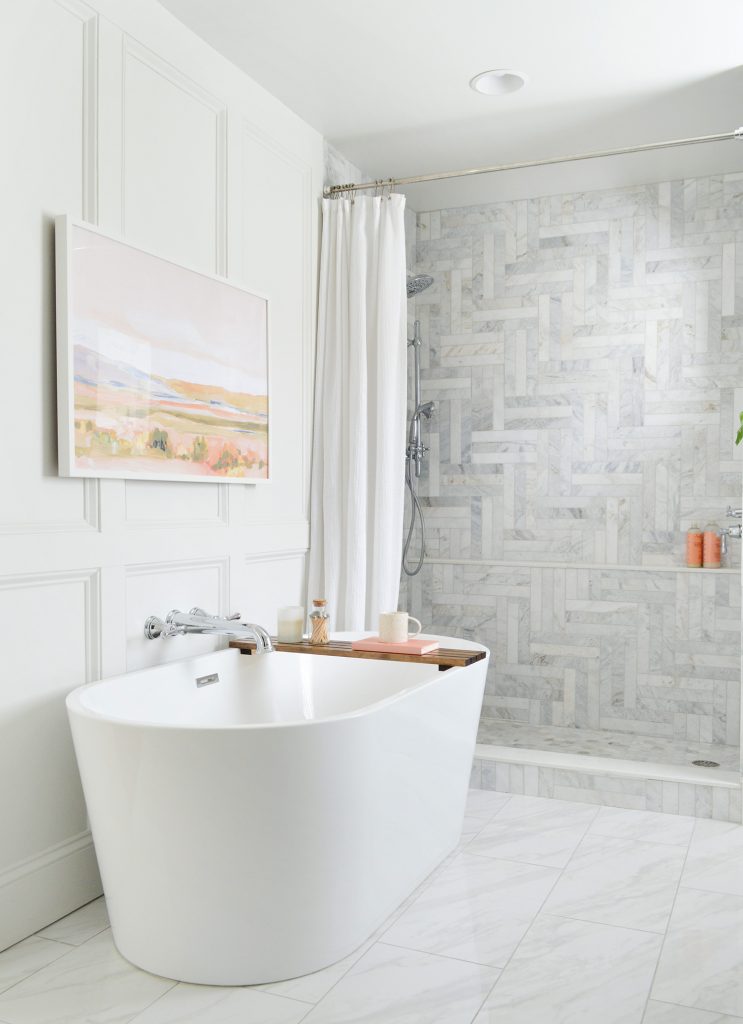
[467, 797, 598, 867]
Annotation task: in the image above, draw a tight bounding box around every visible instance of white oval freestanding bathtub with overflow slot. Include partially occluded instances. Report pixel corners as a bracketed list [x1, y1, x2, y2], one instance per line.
[68, 638, 487, 985]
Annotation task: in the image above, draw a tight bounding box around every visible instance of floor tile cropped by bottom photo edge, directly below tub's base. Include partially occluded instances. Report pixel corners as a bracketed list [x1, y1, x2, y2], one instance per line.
[131, 984, 310, 1024]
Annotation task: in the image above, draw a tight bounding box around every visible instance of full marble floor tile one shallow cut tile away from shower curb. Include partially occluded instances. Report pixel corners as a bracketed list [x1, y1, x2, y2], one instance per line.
[544, 836, 686, 932]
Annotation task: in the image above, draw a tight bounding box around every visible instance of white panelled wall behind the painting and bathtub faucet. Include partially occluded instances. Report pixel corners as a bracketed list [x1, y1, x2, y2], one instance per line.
[0, 0, 322, 947]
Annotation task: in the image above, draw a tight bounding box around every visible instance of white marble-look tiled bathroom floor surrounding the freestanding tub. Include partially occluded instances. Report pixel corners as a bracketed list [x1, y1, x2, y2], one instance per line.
[0, 791, 743, 1024]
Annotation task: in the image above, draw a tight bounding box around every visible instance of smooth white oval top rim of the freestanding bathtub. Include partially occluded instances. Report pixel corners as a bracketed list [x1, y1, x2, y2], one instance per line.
[64, 631, 490, 734]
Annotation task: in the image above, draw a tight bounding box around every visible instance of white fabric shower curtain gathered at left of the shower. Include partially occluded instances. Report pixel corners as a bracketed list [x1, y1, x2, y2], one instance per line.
[308, 195, 407, 630]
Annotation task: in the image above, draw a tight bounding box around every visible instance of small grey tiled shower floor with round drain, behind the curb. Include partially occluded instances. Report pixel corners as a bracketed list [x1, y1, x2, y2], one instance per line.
[477, 718, 740, 771]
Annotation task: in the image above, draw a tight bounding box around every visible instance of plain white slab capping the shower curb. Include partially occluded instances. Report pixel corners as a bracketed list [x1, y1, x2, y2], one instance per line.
[475, 743, 741, 790]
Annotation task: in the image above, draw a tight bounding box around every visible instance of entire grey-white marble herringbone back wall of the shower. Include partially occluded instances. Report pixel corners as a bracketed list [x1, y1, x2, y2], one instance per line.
[403, 174, 743, 743]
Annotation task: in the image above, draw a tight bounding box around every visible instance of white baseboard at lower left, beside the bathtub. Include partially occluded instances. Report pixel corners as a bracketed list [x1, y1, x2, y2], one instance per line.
[0, 831, 102, 949]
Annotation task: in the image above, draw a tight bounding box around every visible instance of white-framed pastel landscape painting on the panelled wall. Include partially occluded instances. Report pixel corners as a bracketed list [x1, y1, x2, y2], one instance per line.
[56, 216, 269, 483]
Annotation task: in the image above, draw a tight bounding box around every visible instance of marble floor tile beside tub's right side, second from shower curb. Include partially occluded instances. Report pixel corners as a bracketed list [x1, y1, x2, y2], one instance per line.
[383, 852, 560, 967]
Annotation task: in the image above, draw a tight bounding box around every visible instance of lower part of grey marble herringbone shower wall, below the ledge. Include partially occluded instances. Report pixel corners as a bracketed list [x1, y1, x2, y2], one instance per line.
[410, 562, 741, 760]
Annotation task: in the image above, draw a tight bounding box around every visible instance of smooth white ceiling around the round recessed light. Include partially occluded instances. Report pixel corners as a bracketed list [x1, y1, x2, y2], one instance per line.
[161, 0, 743, 210]
